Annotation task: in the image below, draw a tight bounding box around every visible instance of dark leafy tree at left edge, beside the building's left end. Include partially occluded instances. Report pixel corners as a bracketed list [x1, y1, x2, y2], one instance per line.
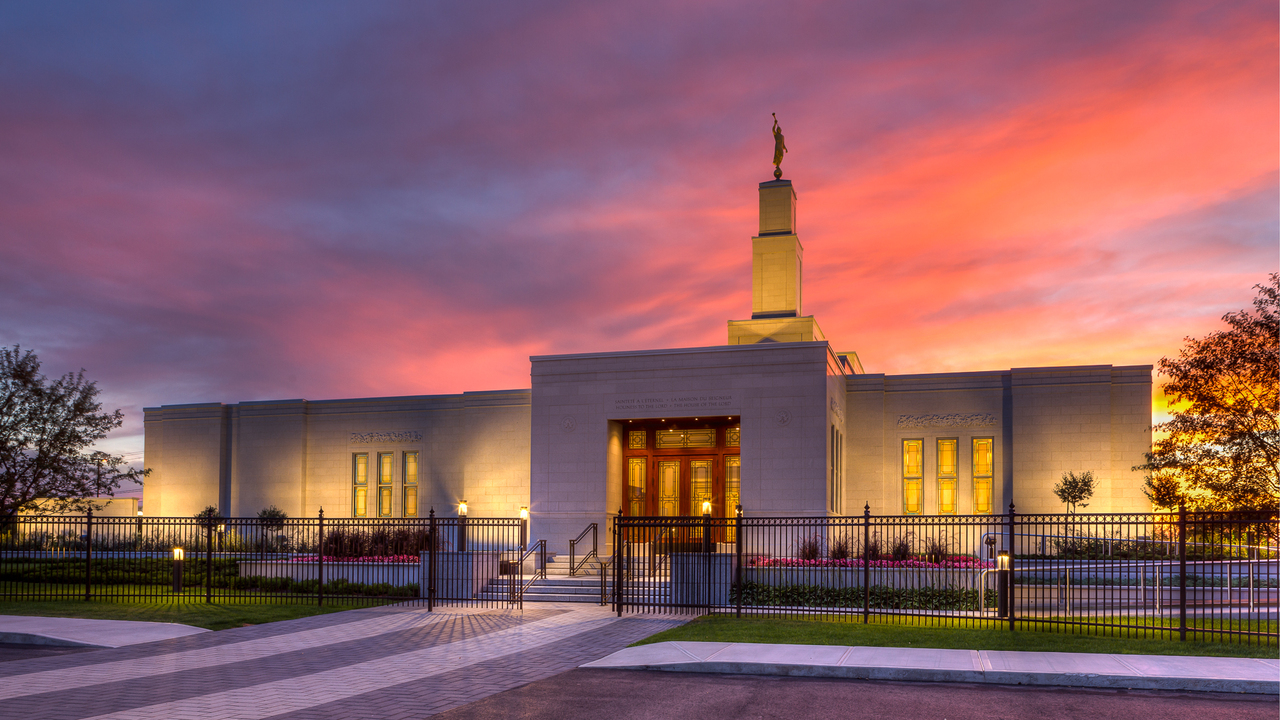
[0, 346, 146, 519]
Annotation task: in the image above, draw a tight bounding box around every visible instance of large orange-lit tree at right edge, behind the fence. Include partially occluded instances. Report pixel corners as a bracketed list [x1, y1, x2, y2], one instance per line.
[1135, 273, 1280, 514]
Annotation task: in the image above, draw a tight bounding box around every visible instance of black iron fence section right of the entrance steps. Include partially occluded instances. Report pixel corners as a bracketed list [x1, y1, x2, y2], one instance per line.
[609, 506, 1280, 646]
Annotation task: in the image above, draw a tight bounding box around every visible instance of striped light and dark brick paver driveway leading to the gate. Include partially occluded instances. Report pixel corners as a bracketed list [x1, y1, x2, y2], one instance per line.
[0, 605, 684, 720]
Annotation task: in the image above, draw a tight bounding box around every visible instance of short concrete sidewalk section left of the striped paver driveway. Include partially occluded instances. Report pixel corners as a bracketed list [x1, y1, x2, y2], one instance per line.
[0, 615, 209, 647]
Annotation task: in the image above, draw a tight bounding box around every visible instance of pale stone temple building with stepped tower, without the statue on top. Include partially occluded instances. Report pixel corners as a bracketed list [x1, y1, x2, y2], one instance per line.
[143, 172, 1152, 548]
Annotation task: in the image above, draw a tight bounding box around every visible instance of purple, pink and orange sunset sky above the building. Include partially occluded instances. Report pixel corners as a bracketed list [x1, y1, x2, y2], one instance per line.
[0, 0, 1280, 486]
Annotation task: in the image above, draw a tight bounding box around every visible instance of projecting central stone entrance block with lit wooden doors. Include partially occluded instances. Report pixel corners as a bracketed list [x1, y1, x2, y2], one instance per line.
[530, 342, 845, 545]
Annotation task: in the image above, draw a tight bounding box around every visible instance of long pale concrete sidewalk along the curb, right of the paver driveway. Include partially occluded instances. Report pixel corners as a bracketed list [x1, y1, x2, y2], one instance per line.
[581, 642, 1280, 694]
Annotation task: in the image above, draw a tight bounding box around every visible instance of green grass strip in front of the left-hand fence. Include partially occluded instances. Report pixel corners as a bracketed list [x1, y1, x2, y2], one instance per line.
[0, 598, 389, 630]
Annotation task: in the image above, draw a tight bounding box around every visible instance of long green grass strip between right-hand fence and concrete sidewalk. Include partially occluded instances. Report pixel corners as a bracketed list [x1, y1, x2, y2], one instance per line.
[635, 615, 1280, 657]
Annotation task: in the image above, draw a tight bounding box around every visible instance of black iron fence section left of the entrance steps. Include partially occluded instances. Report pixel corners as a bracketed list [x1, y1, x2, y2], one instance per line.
[0, 512, 529, 607]
